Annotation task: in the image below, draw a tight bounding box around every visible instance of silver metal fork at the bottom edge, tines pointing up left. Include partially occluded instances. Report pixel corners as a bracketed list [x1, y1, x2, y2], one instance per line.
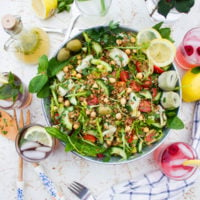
[68, 181, 95, 200]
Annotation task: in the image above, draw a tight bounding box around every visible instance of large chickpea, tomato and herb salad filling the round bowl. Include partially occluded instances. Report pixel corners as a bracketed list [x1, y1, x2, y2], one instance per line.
[29, 23, 183, 161]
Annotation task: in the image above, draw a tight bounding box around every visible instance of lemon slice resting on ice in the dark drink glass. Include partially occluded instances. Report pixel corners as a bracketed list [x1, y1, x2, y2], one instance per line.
[24, 126, 53, 147]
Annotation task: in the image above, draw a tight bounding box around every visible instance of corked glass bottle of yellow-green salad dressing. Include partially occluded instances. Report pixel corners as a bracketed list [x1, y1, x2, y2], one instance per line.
[2, 15, 49, 64]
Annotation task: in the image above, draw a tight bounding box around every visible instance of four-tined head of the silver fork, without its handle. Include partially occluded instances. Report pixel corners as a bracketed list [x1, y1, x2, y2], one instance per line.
[68, 181, 89, 199]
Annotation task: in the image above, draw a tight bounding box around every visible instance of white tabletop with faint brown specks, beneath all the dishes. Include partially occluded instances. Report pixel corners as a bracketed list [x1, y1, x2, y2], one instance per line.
[0, 0, 200, 200]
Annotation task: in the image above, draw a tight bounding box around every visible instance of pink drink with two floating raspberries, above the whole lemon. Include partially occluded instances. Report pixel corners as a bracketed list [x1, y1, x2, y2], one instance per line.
[175, 27, 200, 69]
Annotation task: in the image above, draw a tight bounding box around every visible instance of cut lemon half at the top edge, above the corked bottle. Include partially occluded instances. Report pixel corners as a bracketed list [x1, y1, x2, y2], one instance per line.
[32, 0, 58, 19]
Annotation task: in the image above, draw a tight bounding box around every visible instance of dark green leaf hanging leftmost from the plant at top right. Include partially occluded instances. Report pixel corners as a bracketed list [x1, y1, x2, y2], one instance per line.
[158, 0, 175, 17]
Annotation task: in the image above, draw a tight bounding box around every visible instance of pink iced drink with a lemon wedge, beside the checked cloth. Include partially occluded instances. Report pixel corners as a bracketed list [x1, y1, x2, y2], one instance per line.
[154, 142, 197, 180]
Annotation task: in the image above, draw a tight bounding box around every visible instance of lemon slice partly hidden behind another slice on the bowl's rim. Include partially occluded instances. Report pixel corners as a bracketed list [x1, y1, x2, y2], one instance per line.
[136, 28, 161, 45]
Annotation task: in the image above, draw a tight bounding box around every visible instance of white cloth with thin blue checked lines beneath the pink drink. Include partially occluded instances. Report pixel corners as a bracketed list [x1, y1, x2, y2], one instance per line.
[97, 101, 200, 200]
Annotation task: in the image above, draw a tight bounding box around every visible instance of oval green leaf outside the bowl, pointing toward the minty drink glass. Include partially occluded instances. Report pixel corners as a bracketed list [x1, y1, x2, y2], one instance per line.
[28, 74, 48, 93]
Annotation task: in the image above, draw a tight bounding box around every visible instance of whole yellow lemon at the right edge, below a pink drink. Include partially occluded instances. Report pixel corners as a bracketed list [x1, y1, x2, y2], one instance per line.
[181, 69, 200, 102]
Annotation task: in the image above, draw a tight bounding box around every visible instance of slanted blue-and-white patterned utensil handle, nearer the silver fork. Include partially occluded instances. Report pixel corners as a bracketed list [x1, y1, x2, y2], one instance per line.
[34, 164, 65, 200]
